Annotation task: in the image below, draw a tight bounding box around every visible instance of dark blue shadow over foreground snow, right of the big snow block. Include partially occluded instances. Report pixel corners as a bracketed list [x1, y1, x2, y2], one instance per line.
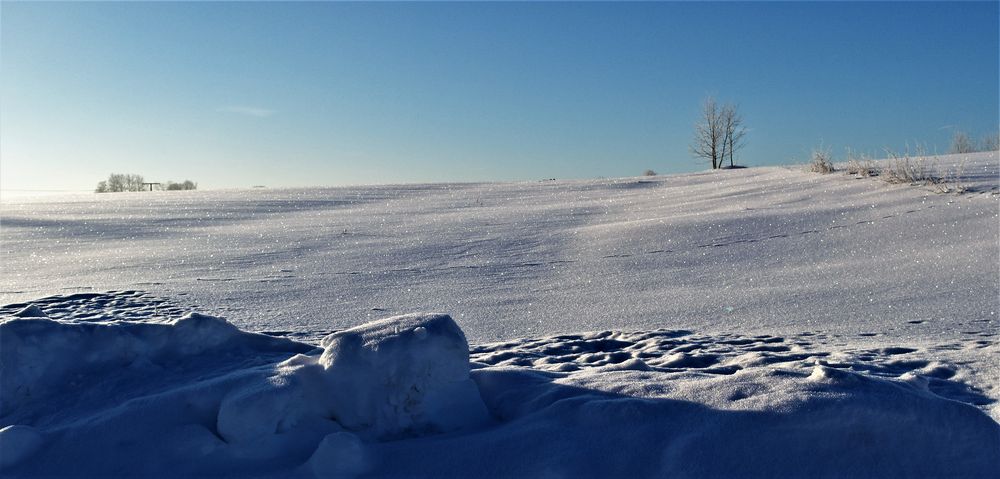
[370, 368, 1000, 477]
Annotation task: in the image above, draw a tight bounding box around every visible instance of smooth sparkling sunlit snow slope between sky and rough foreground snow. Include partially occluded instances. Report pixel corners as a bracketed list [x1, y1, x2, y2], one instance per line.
[0, 153, 1000, 343]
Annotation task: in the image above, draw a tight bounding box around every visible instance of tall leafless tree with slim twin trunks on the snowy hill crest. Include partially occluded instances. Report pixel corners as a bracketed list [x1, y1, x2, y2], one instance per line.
[691, 97, 746, 169]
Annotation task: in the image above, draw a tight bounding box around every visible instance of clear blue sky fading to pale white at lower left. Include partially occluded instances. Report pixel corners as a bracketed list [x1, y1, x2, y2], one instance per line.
[0, 1, 1000, 194]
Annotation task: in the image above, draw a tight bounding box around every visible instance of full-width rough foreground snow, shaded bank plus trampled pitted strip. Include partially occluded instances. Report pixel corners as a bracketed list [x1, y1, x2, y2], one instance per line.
[0, 293, 1000, 477]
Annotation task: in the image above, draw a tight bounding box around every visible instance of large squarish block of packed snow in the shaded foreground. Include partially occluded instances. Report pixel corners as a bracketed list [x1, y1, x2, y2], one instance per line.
[319, 314, 489, 438]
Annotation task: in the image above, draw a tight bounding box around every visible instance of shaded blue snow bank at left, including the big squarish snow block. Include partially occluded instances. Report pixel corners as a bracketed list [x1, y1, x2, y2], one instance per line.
[0, 314, 490, 477]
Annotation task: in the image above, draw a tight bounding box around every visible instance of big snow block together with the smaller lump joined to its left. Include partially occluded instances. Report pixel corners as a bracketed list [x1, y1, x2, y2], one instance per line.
[218, 314, 489, 443]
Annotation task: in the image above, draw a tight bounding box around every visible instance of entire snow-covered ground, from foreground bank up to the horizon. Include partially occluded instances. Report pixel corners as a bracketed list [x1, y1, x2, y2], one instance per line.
[0, 152, 1000, 477]
